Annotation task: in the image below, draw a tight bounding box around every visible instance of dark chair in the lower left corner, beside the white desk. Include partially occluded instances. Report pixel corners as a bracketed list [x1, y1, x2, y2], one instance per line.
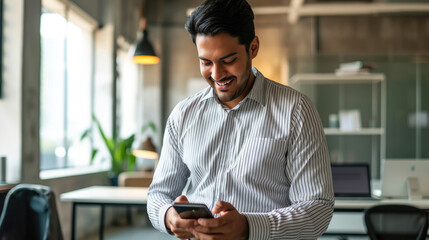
[0, 184, 63, 240]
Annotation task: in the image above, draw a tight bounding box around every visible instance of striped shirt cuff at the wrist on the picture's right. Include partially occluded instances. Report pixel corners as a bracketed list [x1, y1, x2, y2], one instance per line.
[243, 213, 270, 240]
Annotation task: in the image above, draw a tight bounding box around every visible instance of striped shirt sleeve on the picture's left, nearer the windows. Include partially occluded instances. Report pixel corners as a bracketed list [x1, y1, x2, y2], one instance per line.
[147, 109, 189, 232]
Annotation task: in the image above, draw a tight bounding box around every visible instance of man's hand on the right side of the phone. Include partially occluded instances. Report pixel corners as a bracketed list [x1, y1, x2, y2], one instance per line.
[194, 201, 249, 240]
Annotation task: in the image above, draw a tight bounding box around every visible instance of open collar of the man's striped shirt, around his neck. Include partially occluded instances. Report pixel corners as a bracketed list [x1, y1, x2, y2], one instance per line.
[200, 67, 265, 106]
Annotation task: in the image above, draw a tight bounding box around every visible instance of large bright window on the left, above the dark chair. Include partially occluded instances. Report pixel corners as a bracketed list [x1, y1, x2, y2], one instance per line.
[40, 0, 96, 170]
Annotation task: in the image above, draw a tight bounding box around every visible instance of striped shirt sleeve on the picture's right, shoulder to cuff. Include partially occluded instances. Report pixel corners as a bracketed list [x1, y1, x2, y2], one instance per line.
[245, 96, 334, 240]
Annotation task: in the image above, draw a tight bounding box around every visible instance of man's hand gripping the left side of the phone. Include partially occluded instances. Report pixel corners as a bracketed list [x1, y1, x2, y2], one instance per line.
[165, 195, 198, 239]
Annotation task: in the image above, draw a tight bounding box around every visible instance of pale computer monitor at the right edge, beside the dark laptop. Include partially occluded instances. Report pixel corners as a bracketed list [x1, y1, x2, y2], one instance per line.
[381, 159, 429, 199]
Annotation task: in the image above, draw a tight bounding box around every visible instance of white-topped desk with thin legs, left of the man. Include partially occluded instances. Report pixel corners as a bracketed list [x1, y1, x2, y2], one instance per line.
[60, 186, 148, 240]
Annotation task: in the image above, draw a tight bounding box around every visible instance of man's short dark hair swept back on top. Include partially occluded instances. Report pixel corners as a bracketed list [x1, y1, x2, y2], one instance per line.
[185, 0, 255, 51]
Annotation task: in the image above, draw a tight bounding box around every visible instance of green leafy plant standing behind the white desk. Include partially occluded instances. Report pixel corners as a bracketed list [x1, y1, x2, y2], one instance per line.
[80, 114, 156, 185]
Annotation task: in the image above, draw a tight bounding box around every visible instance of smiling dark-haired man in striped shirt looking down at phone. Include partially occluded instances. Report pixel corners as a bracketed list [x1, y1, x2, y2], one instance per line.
[148, 0, 334, 240]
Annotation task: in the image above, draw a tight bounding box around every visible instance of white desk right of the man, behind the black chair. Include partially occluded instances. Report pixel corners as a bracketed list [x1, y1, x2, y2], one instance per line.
[324, 199, 429, 236]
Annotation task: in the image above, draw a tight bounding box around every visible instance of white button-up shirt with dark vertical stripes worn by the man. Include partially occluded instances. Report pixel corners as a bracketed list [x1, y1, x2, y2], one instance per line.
[148, 68, 334, 240]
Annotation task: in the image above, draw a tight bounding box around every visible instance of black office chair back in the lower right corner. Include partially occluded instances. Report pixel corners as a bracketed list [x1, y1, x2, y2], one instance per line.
[365, 205, 428, 240]
